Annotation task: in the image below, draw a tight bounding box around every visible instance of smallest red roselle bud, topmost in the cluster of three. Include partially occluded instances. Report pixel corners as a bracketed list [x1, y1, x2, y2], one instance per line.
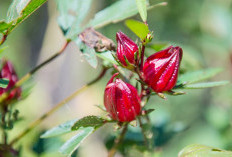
[116, 32, 138, 66]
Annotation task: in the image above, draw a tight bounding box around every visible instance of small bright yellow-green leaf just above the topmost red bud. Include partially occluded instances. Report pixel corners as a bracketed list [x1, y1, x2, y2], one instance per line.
[125, 20, 149, 40]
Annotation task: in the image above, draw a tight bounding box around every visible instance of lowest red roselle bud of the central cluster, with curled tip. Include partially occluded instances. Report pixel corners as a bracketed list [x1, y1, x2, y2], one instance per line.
[104, 73, 141, 122]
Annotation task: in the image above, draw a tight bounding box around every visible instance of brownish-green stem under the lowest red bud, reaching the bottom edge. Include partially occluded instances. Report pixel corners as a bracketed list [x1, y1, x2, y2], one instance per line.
[108, 123, 128, 157]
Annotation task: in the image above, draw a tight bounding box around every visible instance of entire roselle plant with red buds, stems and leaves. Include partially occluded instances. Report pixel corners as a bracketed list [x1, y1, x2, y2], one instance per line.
[0, 0, 232, 157]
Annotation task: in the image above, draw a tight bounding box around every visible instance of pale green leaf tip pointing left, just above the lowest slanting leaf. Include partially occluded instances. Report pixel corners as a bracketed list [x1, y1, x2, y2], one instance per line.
[40, 119, 77, 138]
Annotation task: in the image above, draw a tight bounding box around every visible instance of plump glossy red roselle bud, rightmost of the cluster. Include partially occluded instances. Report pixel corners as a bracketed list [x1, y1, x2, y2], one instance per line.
[143, 46, 183, 93]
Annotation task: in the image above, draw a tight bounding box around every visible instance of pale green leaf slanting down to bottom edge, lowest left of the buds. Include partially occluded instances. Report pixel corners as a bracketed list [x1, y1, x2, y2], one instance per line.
[59, 127, 94, 156]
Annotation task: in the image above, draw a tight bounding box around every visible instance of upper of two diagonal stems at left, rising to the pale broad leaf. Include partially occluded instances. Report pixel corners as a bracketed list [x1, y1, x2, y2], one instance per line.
[0, 41, 70, 104]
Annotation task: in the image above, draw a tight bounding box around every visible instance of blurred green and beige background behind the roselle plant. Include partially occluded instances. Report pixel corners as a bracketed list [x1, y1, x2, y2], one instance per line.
[0, 0, 232, 157]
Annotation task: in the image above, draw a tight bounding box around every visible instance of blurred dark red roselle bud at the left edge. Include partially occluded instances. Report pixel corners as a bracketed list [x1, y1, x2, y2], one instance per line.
[0, 60, 22, 101]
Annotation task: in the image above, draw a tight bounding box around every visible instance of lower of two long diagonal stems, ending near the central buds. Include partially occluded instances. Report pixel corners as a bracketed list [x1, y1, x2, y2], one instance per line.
[10, 68, 108, 145]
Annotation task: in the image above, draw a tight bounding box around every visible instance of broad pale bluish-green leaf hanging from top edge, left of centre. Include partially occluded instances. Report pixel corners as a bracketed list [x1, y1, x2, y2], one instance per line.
[56, 0, 92, 38]
